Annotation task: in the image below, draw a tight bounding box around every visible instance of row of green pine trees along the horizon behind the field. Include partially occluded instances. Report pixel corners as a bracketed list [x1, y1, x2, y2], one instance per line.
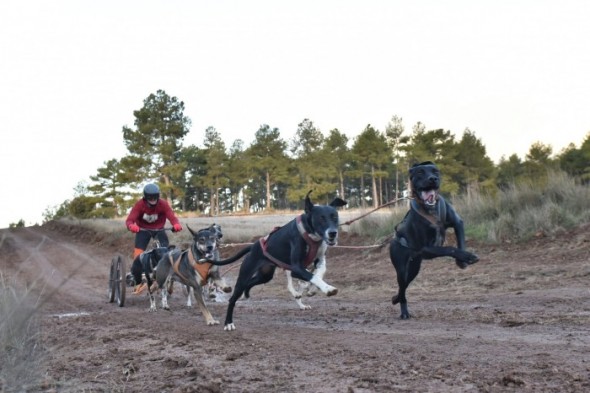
[44, 90, 590, 221]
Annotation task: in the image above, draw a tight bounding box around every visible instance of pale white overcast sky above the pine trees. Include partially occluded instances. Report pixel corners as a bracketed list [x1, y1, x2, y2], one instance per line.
[0, 0, 590, 228]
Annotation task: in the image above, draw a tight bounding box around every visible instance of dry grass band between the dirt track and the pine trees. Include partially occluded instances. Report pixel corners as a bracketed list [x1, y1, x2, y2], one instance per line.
[63, 172, 590, 244]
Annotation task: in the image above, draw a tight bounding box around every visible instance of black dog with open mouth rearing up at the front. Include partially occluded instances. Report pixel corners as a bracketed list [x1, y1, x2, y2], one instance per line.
[389, 161, 478, 319]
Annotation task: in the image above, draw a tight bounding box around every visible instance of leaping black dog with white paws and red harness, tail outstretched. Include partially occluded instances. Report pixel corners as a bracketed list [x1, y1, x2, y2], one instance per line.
[211, 191, 346, 330]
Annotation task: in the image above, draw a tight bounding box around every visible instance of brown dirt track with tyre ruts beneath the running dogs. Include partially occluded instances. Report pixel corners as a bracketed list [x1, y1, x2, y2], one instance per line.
[0, 219, 590, 393]
